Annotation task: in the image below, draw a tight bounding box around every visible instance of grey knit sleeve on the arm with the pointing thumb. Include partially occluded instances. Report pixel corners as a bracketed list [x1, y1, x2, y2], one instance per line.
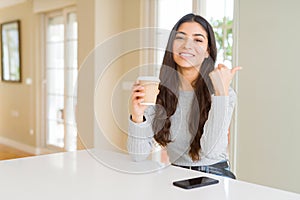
[200, 88, 236, 159]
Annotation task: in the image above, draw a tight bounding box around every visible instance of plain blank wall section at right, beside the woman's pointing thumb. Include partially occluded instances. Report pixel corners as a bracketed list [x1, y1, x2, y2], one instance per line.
[237, 0, 300, 193]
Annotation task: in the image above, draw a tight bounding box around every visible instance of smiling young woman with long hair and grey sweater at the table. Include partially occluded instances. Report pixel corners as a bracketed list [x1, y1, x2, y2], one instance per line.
[127, 14, 241, 178]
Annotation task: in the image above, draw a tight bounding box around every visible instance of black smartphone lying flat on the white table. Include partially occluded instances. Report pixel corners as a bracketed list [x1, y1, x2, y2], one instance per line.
[173, 176, 219, 189]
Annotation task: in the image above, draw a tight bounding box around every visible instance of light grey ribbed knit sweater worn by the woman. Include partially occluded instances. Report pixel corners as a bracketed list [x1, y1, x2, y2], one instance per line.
[127, 88, 236, 166]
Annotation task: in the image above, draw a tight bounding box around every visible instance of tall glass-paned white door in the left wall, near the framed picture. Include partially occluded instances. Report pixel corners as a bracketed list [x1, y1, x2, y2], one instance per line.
[45, 9, 78, 151]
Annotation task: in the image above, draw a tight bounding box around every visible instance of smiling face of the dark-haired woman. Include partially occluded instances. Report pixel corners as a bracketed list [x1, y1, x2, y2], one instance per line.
[173, 22, 209, 69]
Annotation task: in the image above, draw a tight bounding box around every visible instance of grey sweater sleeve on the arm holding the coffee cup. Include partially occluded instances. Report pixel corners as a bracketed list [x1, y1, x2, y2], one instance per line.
[127, 107, 154, 161]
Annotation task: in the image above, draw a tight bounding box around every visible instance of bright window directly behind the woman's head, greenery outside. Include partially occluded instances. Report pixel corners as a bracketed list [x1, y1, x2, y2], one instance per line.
[153, 0, 234, 72]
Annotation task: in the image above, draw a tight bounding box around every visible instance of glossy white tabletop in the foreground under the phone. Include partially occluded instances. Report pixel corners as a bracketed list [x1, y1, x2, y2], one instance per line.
[0, 150, 300, 200]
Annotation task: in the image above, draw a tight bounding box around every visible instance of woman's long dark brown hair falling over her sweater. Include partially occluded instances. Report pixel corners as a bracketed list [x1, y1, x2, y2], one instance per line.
[152, 14, 217, 161]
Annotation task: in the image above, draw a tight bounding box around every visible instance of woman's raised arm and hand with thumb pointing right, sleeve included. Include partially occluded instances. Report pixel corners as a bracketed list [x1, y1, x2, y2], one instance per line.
[200, 64, 242, 159]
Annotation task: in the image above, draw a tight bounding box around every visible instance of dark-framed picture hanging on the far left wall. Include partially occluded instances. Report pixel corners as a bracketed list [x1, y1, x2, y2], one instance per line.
[0, 20, 21, 82]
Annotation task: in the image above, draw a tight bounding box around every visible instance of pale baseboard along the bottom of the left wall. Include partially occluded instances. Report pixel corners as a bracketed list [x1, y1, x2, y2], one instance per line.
[0, 136, 52, 155]
